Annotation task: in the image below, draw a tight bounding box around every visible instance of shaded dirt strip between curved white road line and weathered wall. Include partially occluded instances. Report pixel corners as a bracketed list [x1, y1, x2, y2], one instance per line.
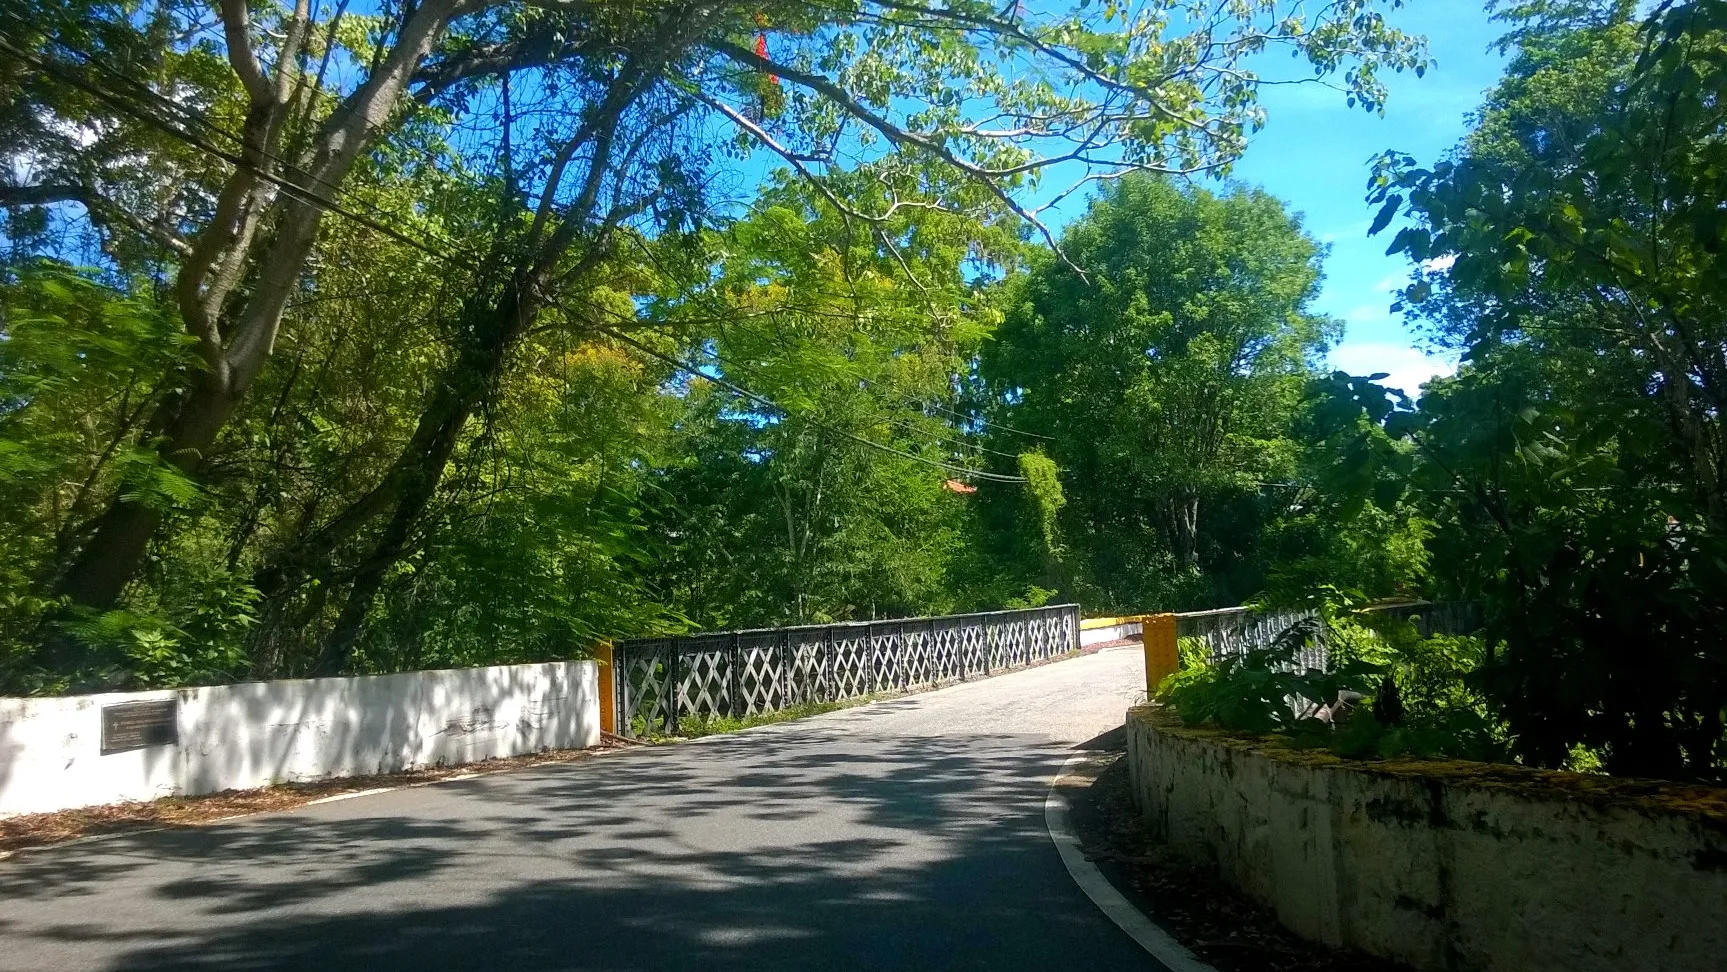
[1069, 751, 1409, 972]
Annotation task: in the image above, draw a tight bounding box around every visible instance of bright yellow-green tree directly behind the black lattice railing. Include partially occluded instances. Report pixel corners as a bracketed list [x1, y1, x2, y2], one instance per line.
[642, 181, 1017, 627]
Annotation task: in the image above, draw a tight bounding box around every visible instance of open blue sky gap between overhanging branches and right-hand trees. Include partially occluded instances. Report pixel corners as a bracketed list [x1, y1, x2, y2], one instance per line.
[1235, 0, 1504, 392]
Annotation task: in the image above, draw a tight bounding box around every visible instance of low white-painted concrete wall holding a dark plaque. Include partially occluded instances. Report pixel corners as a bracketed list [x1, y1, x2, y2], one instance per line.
[0, 661, 599, 817]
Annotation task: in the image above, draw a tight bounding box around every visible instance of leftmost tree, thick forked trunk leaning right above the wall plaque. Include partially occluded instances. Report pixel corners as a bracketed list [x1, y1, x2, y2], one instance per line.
[3, 0, 487, 624]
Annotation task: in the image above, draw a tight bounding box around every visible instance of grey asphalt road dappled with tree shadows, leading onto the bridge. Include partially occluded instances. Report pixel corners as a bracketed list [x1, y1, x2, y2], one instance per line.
[0, 647, 1161, 972]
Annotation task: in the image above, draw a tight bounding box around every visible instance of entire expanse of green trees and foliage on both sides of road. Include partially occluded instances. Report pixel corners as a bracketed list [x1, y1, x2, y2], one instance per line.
[0, 0, 1727, 779]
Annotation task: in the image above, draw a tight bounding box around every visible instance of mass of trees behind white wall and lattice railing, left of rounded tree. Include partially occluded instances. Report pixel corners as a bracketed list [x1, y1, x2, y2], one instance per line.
[0, 0, 1423, 691]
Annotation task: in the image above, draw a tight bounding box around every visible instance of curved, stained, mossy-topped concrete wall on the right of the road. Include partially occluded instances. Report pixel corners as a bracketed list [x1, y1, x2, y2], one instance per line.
[1128, 708, 1727, 972]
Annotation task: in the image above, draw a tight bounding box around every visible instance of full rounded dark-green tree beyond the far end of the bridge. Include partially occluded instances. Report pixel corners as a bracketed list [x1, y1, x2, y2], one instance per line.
[983, 176, 1335, 608]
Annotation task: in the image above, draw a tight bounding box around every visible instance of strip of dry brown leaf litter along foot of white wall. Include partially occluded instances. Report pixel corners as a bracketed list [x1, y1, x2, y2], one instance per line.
[0, 735, 637, 855]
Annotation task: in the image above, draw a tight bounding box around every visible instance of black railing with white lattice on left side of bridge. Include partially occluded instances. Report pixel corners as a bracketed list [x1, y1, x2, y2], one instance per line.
[603, 604, 1079, 735]
